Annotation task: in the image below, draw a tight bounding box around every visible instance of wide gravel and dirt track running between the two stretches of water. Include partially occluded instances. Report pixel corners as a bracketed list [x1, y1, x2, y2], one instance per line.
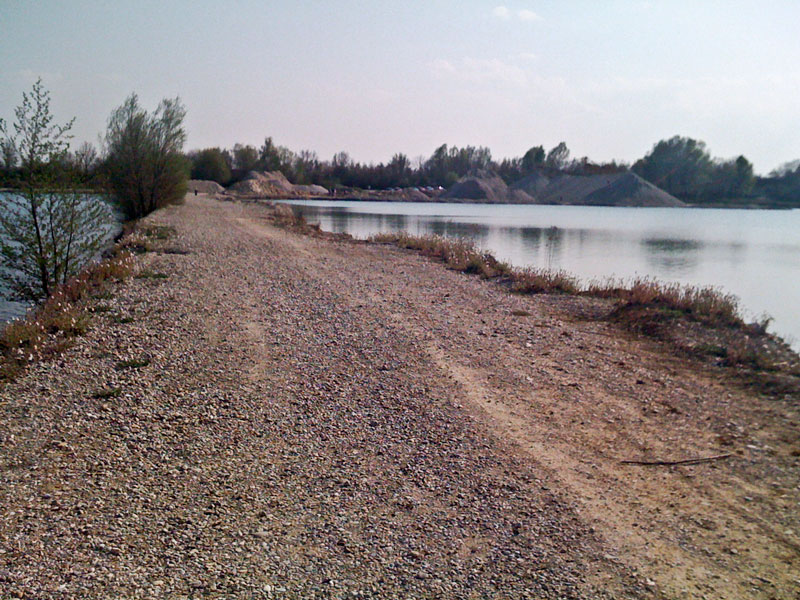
[0, 196, 800, 599]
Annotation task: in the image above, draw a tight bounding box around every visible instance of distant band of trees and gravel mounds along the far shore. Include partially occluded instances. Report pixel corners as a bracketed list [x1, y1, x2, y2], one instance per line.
[0, 82, 800, 208]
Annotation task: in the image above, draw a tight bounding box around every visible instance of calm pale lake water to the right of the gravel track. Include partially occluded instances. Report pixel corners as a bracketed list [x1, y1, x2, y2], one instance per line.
[291, 200, 800, 349]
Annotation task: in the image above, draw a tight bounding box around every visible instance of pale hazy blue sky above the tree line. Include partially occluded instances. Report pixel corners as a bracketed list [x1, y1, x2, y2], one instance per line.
[0, 0, 800, 173]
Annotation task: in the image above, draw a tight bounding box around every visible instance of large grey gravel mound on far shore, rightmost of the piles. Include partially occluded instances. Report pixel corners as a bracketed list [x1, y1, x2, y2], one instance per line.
[512, 171, 683, 206]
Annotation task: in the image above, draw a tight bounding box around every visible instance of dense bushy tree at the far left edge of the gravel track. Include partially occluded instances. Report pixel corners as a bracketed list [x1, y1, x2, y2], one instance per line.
[105, 94, 191, 219]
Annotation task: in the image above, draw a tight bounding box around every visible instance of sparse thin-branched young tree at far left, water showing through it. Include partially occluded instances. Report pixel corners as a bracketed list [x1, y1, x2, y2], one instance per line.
[0, 80, 112, 301]
